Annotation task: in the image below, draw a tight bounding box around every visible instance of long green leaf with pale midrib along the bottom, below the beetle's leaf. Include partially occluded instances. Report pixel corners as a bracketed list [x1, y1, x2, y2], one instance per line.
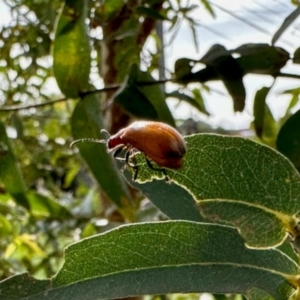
[0, 221, 298, 300]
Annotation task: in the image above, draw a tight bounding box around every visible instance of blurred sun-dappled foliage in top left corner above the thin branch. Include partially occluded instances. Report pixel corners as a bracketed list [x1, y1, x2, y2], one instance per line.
[0, 0, 63, 105]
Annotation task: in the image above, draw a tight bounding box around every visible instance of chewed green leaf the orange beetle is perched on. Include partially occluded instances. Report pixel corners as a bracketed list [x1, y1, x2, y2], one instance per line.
[134, 134, 300, 248]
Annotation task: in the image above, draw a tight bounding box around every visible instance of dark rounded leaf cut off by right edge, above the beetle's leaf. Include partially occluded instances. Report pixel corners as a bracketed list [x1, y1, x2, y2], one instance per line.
[276, 110, 300, 170]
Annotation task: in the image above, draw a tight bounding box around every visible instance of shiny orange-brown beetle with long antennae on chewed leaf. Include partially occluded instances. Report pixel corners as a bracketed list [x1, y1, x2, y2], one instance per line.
[71, 121, 186, 181]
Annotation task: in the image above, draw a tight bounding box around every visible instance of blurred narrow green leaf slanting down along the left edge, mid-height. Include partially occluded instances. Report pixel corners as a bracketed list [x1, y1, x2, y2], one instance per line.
[0, 122, 29, 208]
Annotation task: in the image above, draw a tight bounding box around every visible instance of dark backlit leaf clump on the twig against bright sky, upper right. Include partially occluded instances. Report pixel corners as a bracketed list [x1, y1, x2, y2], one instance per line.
[174, 43, 290, 111]
